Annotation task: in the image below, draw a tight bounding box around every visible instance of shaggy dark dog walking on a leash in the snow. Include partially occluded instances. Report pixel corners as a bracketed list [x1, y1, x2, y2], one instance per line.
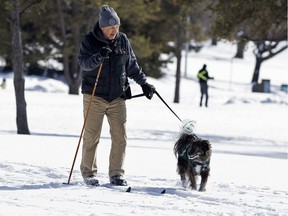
[174, 133, 212, 191]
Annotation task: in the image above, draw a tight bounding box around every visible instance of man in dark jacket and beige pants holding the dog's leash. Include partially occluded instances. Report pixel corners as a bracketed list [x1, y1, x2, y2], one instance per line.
[78, 5, 155, 186]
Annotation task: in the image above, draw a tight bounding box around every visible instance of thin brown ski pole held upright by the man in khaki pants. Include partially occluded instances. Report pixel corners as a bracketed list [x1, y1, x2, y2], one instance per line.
[64, 62, 103, 184]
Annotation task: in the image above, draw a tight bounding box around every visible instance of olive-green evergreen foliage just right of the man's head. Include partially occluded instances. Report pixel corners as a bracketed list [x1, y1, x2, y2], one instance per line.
[111, 0, 163, 78]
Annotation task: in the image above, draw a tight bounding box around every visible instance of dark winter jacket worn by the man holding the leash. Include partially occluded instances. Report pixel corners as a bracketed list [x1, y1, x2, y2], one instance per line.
[78, 23, 146, 102]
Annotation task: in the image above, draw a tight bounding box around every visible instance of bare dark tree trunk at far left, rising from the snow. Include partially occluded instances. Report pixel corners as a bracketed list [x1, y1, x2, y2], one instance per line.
[10, 0, 30, 134]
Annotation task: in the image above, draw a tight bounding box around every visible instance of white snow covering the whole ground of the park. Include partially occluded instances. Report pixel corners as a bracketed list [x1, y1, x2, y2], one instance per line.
[0, 42, 288, 216]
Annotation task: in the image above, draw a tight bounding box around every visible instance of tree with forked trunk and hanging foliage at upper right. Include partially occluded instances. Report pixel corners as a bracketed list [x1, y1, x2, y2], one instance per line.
[211, 0, 288, 83]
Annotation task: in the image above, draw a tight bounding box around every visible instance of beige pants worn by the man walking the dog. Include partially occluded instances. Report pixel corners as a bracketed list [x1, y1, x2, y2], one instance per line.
[80, 94, 127, 177]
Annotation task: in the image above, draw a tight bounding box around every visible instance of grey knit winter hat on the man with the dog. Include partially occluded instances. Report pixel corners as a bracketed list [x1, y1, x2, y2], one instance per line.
[99, 5, 120, 28]
